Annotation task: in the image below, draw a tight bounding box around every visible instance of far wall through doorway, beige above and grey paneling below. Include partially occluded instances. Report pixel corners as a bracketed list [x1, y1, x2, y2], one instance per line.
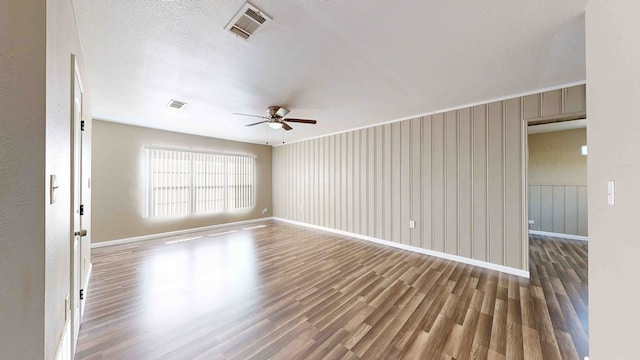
[528, 129, 588, 236]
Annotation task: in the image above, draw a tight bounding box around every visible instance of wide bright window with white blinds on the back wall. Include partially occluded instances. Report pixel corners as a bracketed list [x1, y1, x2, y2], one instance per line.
[145, 148, 255, 216]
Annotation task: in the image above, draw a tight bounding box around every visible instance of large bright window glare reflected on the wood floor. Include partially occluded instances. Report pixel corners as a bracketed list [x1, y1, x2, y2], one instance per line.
[138, 231, 261, 331]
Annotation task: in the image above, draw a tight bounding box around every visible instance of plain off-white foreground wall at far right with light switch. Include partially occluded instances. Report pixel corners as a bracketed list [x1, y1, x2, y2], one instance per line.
[586, 0, 640, 360]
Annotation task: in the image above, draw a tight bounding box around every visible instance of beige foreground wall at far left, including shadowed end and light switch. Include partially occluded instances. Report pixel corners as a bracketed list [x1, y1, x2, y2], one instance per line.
[0, 0, 91, 359]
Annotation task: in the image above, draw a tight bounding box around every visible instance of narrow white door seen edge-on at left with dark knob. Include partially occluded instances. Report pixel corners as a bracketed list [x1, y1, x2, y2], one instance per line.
[70, 57, 86, 354]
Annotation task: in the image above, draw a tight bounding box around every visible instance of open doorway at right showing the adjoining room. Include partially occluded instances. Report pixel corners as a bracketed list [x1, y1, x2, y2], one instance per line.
[527, 119, 589, 359]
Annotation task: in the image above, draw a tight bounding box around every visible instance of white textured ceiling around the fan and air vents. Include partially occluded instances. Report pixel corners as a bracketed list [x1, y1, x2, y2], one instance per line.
[73, 0, 588, 143]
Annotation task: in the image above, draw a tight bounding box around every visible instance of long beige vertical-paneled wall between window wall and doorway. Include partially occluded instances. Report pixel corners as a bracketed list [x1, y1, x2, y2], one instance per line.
[273, 86, 584, 271]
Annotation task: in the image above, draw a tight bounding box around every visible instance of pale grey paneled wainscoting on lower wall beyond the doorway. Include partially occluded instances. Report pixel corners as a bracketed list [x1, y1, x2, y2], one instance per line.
[529, 185, 587, 236]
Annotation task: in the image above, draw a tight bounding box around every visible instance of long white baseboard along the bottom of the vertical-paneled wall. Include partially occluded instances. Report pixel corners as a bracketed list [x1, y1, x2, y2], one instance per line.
[273, 217, 529, 279]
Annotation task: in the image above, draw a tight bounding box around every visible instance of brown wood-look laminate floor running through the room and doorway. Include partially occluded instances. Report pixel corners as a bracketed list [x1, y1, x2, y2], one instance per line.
[76, 222, 588, 360]
